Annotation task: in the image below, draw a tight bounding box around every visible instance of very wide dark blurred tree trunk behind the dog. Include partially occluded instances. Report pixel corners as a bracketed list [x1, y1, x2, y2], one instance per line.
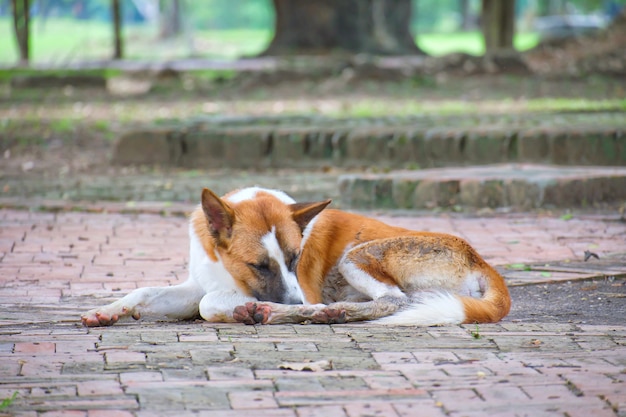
[263, 0, 424, 55]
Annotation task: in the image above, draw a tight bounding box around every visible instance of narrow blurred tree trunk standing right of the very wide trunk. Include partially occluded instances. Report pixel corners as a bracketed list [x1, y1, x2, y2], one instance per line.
[481, 0, 515, 54]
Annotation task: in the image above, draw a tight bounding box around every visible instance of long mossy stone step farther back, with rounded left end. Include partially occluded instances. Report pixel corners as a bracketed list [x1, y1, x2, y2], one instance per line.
[113, 112, 626, 169]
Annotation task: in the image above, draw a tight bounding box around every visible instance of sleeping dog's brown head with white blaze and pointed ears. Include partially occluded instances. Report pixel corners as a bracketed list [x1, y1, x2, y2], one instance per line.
[202, 188, 330, 304]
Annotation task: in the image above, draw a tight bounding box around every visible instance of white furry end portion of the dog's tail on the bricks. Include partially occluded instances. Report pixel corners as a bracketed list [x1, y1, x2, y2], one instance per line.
[374, 292, 465, 326]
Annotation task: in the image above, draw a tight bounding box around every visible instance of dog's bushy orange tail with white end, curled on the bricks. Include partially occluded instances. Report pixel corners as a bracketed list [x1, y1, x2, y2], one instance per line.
[375, 268, 511, 326]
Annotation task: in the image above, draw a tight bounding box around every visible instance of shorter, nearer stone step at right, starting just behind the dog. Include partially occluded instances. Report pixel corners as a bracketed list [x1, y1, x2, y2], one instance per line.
[339, 164, 626, 210]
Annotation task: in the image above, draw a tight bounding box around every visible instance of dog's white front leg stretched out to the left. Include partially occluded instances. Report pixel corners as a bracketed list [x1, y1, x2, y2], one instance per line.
[81, 279, 204, 327]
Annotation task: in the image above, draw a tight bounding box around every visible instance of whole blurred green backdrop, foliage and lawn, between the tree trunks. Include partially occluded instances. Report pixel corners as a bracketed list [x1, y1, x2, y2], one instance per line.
[0, 0, 626, 66]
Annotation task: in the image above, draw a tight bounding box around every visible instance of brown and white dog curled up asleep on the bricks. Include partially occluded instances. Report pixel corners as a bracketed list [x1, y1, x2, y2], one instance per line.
[82, 187, 511, 326]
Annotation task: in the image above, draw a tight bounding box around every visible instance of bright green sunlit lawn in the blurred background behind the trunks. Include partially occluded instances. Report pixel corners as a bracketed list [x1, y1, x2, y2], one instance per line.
[0, 17, 539, 66]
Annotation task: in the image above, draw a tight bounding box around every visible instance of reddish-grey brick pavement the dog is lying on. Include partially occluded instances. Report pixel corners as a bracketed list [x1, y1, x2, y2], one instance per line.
[0, 204, 626, 417]
